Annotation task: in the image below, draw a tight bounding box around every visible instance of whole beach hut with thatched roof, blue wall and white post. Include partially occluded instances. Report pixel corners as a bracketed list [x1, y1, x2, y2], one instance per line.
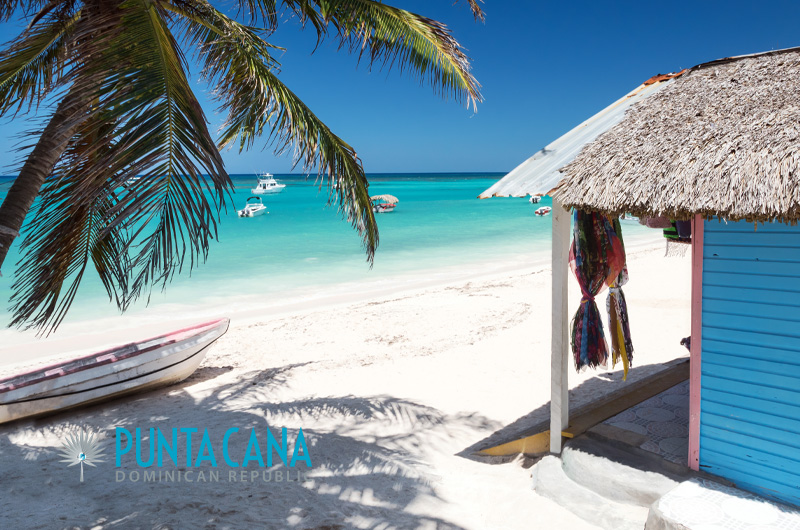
[483, 48, 800, 505]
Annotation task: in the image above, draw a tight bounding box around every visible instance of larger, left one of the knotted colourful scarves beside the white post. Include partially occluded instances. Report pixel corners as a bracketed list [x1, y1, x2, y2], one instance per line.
[569, 209, 625, 371]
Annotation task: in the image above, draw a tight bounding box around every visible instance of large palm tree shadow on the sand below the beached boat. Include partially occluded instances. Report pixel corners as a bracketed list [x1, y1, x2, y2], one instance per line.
[0, 358, 497, 530]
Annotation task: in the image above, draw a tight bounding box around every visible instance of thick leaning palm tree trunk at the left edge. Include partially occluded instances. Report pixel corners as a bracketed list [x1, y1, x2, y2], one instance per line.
[0, 92, 84, 274]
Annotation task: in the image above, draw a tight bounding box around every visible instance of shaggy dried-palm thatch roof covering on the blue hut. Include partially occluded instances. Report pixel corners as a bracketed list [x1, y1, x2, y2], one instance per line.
[551, 48, 800, 223]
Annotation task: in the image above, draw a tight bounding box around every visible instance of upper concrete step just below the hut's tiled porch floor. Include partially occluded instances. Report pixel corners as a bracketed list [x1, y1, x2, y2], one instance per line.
[561, 436, 691, 507]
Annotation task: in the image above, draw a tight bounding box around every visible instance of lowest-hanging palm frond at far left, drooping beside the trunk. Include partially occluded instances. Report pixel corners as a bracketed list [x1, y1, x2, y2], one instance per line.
[11, 114, 127, 333]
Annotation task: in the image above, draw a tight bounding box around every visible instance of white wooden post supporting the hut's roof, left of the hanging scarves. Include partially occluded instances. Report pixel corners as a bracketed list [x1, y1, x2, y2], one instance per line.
[550, 199, 570, 454]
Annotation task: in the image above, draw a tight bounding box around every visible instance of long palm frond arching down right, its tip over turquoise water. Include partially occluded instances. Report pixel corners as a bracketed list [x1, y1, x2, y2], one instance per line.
[169, 2, 378, 262]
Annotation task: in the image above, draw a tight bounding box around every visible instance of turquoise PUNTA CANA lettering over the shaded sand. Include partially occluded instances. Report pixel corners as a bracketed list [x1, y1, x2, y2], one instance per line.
[114, 427, 312, 468]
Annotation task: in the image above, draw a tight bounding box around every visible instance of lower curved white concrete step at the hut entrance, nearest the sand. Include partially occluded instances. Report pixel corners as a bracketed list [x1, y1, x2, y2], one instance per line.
[531, 456, 648, 530]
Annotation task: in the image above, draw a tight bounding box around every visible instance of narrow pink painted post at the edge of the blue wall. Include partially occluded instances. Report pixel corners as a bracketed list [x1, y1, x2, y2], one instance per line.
[689, 215, 703, 471]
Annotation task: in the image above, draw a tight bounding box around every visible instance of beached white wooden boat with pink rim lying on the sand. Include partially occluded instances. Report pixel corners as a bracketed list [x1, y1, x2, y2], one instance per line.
[0, 318, 229, 423]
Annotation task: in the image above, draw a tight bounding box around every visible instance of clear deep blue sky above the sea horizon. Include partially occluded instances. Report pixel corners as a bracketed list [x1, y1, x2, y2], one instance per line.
[0, 0, 800, 174]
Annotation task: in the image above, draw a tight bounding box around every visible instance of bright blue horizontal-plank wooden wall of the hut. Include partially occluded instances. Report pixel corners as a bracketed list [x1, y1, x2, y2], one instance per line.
[700, 220, 800, 505]
